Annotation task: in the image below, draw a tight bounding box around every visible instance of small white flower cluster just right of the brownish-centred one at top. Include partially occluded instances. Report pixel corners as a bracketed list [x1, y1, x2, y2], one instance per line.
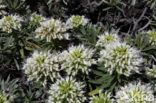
[66, 15, 89, 29]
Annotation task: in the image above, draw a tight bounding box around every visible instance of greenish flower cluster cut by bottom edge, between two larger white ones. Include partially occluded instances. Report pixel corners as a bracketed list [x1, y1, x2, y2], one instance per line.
[90, 92, 114, 103]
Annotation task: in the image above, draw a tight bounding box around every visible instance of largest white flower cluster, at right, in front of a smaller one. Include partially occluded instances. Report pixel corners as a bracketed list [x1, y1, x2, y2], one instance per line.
[98, 42, 143, 76]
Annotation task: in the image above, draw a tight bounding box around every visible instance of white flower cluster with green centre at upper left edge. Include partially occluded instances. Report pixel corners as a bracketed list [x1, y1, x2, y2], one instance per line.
[0, 15, 23, 33]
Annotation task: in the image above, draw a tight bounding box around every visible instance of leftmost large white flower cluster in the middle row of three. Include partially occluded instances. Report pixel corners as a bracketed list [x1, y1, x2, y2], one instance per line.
[23, 51, 60, 86]
